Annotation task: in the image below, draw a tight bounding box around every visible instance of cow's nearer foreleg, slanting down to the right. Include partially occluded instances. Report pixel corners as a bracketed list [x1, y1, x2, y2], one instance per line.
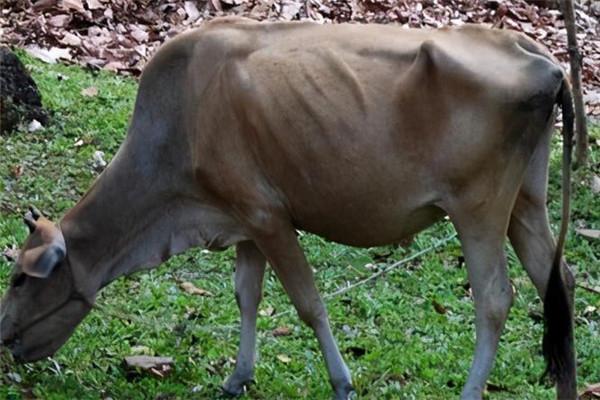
[252, 228, 353, 400]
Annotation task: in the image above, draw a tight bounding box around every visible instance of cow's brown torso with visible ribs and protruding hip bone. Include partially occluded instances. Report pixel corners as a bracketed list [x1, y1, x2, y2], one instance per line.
[148, 20, 562, 245]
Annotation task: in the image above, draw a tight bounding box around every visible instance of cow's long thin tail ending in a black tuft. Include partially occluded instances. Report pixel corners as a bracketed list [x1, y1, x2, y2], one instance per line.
[543, 76, 577, 400]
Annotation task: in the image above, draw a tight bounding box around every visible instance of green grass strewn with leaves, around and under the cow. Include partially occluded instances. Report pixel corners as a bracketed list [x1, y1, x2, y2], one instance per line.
[0, 53, 600, 400]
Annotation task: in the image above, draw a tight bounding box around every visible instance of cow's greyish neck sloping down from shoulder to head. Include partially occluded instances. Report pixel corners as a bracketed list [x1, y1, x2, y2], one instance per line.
[60, 136, 236, 297]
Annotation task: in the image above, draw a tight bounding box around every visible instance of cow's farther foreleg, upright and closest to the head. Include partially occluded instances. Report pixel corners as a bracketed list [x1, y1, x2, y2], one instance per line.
[223, 242, 266, 396]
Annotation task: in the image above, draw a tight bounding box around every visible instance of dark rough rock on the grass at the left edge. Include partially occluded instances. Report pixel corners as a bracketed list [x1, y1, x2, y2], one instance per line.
[0, 46, 48, 135]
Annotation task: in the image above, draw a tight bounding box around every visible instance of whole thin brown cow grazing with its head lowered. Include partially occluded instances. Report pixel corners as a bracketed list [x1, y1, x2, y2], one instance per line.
[0, 18, 577, 400]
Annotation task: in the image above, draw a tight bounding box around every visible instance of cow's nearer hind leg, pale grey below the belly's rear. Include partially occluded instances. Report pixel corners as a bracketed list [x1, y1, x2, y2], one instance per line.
[457, 217, 513, 400]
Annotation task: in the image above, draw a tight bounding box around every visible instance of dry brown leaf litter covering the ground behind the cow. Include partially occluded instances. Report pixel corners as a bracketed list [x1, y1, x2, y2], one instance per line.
[0, 0, 600, 116]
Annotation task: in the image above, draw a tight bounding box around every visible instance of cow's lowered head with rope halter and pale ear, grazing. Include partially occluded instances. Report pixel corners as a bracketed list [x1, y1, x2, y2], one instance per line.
[0, 208, 91, 361]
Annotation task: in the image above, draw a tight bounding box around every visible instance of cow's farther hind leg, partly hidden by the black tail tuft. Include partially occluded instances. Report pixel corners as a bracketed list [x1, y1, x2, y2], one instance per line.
[508, 130, 577, 400]
